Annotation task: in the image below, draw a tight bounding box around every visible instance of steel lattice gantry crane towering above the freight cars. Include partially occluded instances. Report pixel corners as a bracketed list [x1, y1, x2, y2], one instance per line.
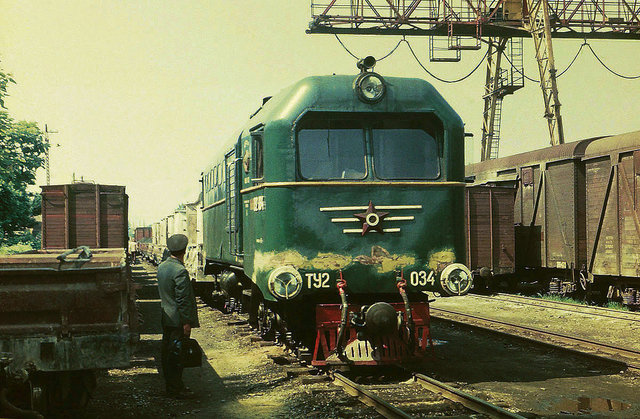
[307, 0, 640, 160]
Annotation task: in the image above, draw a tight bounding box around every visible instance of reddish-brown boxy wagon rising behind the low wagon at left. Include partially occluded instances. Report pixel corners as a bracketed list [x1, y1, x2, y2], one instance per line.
[41, 183, 128, 249]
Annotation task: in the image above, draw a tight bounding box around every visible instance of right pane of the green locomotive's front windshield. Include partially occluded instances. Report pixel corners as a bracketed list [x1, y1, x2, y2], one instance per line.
[372, 128, 440, 180]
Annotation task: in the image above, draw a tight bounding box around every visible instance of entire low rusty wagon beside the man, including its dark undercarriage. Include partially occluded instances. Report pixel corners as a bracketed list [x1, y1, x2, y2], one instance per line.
[0, 248, 138, 417]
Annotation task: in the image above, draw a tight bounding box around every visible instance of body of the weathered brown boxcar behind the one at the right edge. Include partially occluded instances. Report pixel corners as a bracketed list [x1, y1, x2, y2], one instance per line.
[466, 139, 596, 272]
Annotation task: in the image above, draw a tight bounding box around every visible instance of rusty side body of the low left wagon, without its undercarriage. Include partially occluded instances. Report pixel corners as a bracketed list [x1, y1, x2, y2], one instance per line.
[0, 249, 138, 373]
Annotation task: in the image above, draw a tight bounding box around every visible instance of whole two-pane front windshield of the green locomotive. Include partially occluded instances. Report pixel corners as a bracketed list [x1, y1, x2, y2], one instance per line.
[297, 112, 441, 180]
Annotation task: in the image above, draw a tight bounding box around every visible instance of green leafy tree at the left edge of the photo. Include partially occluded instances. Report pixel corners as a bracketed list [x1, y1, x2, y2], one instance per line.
[0, 65, 48, 245]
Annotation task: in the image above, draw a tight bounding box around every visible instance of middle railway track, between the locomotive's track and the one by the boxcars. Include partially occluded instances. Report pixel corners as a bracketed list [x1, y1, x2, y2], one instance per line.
[431, 308, 640, 373]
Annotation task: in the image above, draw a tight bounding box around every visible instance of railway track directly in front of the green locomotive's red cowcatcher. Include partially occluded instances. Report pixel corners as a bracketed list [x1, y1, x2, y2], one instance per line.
[332, 372, 522, 419]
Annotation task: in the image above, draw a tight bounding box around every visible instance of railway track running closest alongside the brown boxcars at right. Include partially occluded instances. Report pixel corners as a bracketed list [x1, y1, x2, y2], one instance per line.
[469, 293, 640, 323]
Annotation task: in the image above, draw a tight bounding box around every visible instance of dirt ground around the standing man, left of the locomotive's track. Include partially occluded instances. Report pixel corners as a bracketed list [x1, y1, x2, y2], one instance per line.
[77, 304, 380, 418]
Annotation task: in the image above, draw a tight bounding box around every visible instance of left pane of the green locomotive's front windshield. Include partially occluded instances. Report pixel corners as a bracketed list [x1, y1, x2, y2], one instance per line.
[298, 128, 367, 180]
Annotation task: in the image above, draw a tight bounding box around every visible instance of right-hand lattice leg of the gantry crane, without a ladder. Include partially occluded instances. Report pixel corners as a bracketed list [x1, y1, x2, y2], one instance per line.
[524, 0, 564, 145]
